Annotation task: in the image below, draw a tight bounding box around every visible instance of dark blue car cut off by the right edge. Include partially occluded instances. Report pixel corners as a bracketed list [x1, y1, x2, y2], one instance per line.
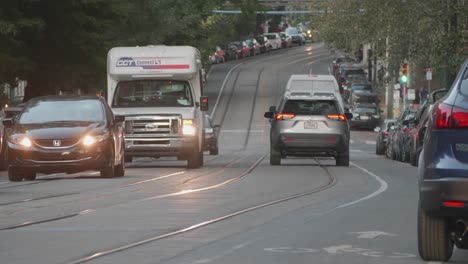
[418, 59, 468, 261]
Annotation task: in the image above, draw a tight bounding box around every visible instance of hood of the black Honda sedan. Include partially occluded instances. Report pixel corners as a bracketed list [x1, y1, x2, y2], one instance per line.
[12, 122, 105, 139]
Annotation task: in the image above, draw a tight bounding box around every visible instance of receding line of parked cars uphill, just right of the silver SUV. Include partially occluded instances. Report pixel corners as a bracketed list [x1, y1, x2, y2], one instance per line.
[332, 55, 381, 129]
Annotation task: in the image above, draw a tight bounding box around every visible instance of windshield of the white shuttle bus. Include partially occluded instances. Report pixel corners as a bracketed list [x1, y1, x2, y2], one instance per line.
[112, 80, 193, 107]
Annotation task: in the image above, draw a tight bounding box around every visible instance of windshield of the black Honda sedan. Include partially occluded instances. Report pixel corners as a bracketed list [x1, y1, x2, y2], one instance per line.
[18, 99, 104, 124]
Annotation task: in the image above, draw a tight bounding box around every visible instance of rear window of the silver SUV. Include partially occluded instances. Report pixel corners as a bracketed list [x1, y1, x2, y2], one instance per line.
[283, 100, 339, 115]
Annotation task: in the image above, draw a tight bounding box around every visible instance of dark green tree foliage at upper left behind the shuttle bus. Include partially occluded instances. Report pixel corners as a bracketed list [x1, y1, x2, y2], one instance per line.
[0, 0, 258, 96]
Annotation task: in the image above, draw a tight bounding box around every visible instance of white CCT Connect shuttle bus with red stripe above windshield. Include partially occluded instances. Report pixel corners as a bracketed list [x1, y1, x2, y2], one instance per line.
[107, 45, 208, 168]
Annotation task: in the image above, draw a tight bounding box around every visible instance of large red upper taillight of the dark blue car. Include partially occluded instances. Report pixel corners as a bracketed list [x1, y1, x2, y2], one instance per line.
[434, 103, 468, 129]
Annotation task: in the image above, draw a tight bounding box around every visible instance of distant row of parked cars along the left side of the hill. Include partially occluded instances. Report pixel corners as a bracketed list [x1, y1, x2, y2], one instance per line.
[208, 27, 306, 64]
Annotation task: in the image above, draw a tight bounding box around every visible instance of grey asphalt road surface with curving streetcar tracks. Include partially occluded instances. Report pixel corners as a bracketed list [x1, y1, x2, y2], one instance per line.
[0, 43, 468, 264]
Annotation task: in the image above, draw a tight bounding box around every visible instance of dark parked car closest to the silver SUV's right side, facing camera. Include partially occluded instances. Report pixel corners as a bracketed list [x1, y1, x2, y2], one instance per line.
[350, 103, 380, 129]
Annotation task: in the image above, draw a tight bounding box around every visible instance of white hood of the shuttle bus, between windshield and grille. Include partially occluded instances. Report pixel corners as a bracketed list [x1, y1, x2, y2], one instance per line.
[112, 107, 196, 119]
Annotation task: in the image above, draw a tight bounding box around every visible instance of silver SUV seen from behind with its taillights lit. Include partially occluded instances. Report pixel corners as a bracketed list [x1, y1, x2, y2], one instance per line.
[264, 92, 352, 166]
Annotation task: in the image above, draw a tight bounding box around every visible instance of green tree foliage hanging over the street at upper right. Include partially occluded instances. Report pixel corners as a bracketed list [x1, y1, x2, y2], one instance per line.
[320, 0, 468, 84]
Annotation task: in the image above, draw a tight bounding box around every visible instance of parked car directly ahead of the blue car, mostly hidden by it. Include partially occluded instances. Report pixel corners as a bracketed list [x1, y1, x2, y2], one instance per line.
[405, 89, 447, 166]
